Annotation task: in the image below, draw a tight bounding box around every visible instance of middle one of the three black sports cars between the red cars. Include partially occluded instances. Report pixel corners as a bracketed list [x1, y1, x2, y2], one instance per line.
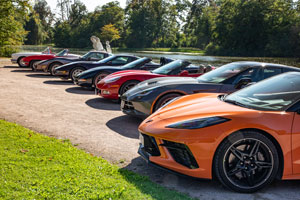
[54, 55, 139, 81]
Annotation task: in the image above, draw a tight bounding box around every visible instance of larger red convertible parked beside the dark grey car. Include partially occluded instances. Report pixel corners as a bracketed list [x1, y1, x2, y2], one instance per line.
[96, 60, 203, 100]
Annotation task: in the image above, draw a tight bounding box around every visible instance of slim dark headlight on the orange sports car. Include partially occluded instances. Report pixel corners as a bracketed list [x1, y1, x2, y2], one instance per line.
[166, 117, 230, 129]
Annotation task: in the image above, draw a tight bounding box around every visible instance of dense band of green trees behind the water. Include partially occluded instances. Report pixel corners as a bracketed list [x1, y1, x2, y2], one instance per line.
[11, 0, 300, 57]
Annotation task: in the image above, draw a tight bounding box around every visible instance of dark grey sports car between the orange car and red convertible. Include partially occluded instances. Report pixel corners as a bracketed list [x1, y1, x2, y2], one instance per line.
[121, 62, 300, 118]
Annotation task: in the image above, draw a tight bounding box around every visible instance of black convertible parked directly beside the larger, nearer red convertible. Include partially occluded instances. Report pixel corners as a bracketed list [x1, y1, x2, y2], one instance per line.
[74, 57, 173, 87]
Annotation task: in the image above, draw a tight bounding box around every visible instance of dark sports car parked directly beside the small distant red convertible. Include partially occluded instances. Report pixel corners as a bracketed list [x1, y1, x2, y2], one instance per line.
[33, 50, 111, 75]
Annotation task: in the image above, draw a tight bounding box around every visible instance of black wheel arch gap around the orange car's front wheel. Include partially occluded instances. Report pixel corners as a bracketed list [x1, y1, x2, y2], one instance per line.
[211, 128, 284, 179]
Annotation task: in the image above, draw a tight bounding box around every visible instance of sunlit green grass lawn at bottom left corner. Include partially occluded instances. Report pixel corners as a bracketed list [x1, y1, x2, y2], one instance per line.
[0, 120, 190, 200]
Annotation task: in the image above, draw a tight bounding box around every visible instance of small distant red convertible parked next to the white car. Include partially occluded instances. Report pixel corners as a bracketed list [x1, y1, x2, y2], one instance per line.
[23, 49, 80, 69]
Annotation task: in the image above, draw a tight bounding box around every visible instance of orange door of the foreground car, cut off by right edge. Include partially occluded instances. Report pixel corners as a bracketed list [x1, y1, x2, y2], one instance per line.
[291, 103, 300, 174]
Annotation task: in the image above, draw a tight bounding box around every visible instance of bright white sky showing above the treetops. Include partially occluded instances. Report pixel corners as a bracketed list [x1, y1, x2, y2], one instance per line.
[46, 0, 126, 12]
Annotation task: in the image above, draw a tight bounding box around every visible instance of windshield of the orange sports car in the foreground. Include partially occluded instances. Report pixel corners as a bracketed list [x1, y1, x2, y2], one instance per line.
[224, 72, 300, 111]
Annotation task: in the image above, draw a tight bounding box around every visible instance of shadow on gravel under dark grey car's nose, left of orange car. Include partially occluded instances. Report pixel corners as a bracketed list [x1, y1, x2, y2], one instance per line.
[106, 115, 142, 139]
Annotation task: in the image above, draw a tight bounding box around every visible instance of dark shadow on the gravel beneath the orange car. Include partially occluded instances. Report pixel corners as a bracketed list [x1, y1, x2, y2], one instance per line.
[120, 156, 300, 200]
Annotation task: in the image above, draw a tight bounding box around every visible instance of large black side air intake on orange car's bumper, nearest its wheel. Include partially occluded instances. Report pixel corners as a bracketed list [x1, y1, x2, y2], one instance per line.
[160, 140, 199, 169]
